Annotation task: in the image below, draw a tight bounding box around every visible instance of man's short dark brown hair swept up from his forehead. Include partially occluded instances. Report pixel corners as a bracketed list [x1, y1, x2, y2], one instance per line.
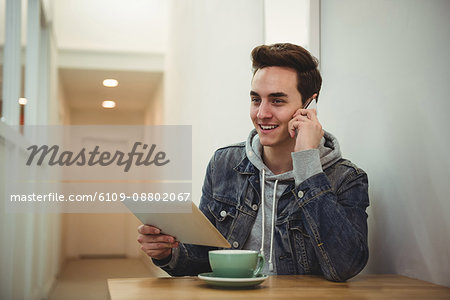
[252, 43, 322, 104]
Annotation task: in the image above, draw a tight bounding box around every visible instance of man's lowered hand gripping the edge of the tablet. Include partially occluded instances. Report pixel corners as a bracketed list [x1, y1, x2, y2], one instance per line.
[137, 225, 179, 260]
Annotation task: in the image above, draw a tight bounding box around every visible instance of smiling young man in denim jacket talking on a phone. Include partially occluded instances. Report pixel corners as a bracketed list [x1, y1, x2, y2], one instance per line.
[138, 43, 369, 281]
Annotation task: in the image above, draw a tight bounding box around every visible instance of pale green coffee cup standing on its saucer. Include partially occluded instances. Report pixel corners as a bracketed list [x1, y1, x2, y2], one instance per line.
[209, 250, 264, 278]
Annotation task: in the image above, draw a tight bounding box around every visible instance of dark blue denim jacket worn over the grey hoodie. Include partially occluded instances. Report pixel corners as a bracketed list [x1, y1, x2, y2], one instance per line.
[153, 143, 369, 281]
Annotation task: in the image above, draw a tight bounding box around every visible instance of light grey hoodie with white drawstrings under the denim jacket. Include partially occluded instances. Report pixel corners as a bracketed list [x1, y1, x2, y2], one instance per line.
[244, 129, 341, 275]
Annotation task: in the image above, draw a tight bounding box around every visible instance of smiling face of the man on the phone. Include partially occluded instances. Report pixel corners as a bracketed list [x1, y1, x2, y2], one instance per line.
[250, 67, 302, 150]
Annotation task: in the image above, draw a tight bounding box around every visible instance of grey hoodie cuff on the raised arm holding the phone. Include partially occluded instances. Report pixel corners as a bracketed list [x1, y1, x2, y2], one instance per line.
[291, 149, 323, 186]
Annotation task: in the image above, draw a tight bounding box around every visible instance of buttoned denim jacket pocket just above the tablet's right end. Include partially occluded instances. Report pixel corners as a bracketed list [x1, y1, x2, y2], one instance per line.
[208, 198, 237, 238]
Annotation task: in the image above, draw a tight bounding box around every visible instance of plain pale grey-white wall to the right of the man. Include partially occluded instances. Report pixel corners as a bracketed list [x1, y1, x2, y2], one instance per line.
[319, 0, 450, 285]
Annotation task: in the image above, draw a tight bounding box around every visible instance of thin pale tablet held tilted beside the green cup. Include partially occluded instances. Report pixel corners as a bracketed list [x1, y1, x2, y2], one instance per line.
[130, 202, 231, 248]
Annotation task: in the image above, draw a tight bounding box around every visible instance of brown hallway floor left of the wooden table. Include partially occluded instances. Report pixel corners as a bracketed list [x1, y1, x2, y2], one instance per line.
[49, 258, 165, 300]
